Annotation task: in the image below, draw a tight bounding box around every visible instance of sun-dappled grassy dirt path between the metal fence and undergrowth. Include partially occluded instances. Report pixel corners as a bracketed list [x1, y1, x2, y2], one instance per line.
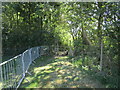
[20, 56, 104, 88]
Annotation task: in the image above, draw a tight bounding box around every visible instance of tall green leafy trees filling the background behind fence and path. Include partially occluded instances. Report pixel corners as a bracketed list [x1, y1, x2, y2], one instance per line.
[2, 2, 120, 87]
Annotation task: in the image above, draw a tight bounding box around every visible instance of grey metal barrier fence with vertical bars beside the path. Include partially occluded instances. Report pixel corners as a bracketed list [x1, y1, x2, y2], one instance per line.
[0, 46, 48, 89]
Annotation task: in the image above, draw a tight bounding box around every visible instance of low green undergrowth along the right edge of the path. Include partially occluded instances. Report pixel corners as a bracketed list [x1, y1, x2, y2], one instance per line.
[71, 56, 120, 88]
